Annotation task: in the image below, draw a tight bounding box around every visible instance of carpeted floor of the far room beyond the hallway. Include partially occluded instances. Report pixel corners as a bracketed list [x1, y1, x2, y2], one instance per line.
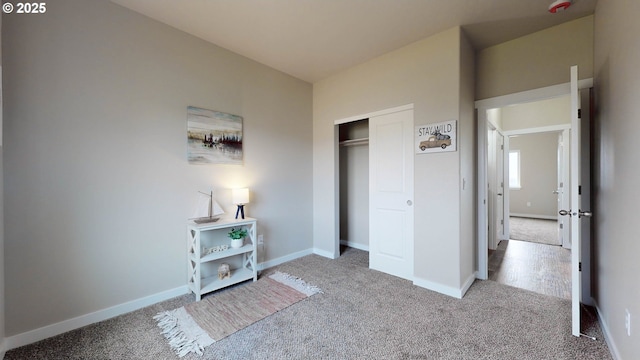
[509, 216, 562, 245]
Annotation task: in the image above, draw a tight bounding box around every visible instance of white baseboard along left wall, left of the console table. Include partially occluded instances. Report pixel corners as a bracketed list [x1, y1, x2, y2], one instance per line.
[3, 285, 189, 351]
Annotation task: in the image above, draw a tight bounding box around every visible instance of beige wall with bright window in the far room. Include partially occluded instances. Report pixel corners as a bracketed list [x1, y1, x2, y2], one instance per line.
[509, 133, 558, 219]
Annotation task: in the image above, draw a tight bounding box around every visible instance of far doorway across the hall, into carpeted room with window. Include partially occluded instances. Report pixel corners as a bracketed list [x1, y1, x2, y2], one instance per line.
[505, 128, 570, 248]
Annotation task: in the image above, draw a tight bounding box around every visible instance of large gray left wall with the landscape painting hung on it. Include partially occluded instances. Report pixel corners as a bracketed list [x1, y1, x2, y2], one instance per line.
[2, 0, 313, 336]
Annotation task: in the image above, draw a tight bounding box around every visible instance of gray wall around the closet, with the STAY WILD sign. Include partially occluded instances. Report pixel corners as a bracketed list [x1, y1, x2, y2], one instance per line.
[313, 28, 475, 292]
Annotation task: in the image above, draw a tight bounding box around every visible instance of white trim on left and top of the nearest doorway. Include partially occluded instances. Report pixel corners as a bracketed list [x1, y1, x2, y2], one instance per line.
[475, 78, 593, 280]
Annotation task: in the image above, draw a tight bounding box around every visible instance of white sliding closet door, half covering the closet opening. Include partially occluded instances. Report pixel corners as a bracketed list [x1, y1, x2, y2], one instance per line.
[369, 110, 414, 280]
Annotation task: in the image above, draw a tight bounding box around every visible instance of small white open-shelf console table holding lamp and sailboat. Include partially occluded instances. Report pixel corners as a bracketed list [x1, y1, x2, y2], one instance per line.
[187, 218, 258, 301]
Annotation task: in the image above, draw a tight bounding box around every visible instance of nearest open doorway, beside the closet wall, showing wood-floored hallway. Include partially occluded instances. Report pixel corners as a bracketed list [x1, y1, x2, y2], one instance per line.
[487, 95, 571, 299]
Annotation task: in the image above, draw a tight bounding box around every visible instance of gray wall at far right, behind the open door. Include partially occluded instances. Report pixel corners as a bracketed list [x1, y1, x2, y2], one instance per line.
[592, 1, 640, 359]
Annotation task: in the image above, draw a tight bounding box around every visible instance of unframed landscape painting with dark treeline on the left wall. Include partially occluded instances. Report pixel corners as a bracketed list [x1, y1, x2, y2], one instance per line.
[187, 106, 242, 164]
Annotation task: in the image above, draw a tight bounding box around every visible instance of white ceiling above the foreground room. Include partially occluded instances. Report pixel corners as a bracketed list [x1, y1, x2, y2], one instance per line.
[111, 0, 597, 83]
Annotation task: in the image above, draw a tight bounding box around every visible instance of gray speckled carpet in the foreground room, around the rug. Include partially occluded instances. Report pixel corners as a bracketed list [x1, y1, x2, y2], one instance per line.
[5, 249, 611, 360]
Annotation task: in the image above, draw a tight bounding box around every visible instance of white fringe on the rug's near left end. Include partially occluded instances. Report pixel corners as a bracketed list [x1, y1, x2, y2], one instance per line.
[153, 308, 214, 357]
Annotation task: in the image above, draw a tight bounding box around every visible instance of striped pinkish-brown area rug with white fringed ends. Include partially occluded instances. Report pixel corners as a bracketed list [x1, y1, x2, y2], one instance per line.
[154, 272, 322, 357]
